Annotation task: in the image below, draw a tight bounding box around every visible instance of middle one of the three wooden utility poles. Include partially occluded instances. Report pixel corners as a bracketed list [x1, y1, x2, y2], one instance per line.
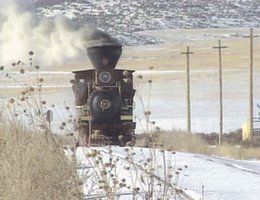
[213, 40, 227, 146]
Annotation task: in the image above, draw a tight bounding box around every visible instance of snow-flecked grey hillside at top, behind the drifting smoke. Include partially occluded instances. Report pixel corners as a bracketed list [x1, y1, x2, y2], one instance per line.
[35, 0, 260, 45]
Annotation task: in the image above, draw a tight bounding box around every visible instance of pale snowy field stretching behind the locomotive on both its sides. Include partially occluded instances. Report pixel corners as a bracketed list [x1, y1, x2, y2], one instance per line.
[0, 65, 260, 133]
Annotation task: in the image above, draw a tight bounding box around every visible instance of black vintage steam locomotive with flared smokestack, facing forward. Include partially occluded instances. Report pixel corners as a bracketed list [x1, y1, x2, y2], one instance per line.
[72, 39, 136, 146]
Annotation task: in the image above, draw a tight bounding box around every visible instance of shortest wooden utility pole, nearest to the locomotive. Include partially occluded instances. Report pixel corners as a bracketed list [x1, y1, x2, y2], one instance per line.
[181, 47, 194, 133]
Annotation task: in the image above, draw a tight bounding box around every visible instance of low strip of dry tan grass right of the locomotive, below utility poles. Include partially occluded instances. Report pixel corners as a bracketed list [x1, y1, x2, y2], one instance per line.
[136, 130, 260, 159]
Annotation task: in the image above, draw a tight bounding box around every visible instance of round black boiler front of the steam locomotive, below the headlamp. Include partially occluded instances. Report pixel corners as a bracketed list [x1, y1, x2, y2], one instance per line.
[89, 90, 121, 121]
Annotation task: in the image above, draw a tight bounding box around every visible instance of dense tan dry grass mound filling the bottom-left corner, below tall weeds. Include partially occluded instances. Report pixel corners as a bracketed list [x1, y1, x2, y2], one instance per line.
[0, 119, 81, 200]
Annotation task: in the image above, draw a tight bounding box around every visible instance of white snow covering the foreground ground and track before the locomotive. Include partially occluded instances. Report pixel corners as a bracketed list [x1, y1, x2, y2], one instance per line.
[73, 146, 260, 200]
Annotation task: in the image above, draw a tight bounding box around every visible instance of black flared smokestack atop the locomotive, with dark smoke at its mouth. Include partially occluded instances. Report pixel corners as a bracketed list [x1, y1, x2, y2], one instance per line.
[87, 30, 122, 69]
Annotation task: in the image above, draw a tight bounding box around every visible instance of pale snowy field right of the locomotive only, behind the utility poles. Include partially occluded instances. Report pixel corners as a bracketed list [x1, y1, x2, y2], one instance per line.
[133, 68, 260, 133]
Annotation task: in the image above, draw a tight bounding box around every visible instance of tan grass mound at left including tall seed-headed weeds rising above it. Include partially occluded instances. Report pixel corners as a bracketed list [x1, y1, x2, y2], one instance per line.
[0, 55, 82, 200]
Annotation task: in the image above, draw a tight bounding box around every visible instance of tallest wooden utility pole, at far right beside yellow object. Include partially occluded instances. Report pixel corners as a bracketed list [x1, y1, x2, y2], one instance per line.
[245, 28, 258, 141]
